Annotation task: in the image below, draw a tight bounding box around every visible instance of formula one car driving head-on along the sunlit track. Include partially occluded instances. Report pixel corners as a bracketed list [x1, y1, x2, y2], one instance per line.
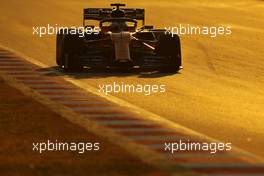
[56, 4, 182, 72]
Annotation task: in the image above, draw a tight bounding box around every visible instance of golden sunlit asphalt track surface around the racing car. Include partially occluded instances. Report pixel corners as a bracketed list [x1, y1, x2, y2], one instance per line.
[0, 0, 264, 157]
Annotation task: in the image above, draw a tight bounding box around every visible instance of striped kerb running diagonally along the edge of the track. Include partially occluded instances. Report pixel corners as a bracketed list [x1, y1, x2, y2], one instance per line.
[0, 47, 264, 176]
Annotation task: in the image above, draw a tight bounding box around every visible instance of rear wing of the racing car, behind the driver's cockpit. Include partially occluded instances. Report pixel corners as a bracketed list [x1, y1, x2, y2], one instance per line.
[83, 8, 145, 25]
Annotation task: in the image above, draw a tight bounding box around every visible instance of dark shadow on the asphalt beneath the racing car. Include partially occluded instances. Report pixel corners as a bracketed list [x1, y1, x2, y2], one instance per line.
[38, 66, 180, 79]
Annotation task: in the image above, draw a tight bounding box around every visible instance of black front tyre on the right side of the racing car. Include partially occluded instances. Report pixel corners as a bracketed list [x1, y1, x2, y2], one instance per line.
[156, 34, 182, 72]
